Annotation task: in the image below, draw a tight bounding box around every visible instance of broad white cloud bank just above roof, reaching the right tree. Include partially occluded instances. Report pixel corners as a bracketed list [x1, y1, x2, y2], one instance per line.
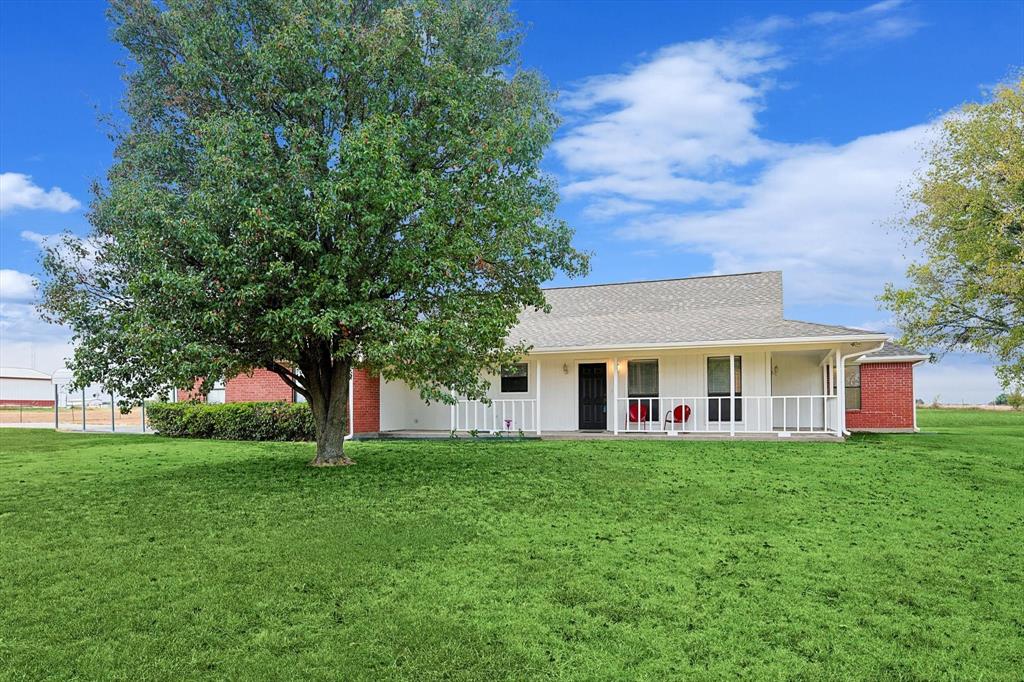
[621, 125, 930, 305]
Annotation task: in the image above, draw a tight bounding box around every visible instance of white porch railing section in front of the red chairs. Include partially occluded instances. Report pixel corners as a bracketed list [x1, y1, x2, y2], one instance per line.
[614, 395, 839, 433]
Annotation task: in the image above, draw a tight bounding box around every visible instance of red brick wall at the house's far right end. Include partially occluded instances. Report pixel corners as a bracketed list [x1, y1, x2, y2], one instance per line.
[846, 363, 913, 429]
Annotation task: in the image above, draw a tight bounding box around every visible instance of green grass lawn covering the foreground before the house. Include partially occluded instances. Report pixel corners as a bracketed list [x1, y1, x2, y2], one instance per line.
[0, 410, 1024, 680]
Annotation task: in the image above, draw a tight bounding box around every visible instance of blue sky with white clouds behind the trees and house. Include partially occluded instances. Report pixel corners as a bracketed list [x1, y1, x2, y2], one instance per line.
[0, 0, 1024, 401]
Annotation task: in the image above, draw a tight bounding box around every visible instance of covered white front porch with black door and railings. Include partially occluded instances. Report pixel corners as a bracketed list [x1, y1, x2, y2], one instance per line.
[381, 343, 876, 438]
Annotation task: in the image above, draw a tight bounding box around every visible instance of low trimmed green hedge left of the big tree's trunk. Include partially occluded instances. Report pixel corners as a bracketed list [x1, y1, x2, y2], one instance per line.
[146, 402, 316, 440]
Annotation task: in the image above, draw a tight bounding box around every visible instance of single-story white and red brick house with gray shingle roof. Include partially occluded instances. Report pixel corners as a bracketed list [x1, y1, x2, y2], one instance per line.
[197, 271, 929, 437]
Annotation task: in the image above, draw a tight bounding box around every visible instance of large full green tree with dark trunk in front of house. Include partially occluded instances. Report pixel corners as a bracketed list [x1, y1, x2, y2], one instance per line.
[42, 0, 587, 465]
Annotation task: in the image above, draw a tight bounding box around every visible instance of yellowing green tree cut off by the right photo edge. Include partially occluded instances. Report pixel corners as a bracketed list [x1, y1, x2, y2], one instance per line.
[881, 79, 1024, 391]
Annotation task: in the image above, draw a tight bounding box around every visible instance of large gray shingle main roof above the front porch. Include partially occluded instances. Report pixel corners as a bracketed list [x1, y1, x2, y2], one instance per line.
[509, 271, 888, 350]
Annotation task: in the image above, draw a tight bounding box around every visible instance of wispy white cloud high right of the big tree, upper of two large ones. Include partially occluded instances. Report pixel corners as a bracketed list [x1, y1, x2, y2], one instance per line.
[554, 40, 786, 202]
